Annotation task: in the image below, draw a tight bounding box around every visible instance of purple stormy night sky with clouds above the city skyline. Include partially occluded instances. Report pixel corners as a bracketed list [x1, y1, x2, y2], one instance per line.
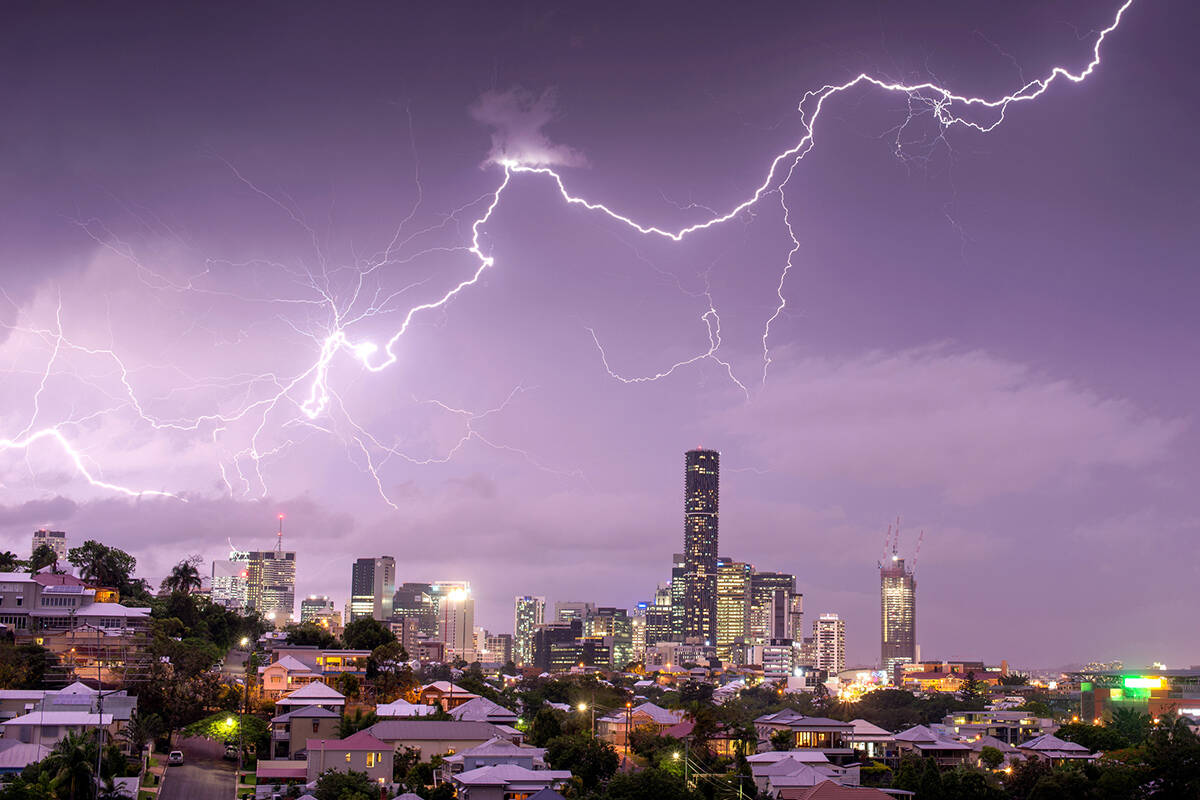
[0, 0, 1200, 667]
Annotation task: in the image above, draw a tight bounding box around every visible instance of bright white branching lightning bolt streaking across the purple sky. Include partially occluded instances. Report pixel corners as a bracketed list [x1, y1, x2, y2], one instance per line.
[0, 0, 1133, 507]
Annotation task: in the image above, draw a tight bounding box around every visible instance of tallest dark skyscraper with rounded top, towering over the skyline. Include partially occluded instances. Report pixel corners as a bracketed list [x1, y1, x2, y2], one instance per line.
[683, 449, 721, 645]
